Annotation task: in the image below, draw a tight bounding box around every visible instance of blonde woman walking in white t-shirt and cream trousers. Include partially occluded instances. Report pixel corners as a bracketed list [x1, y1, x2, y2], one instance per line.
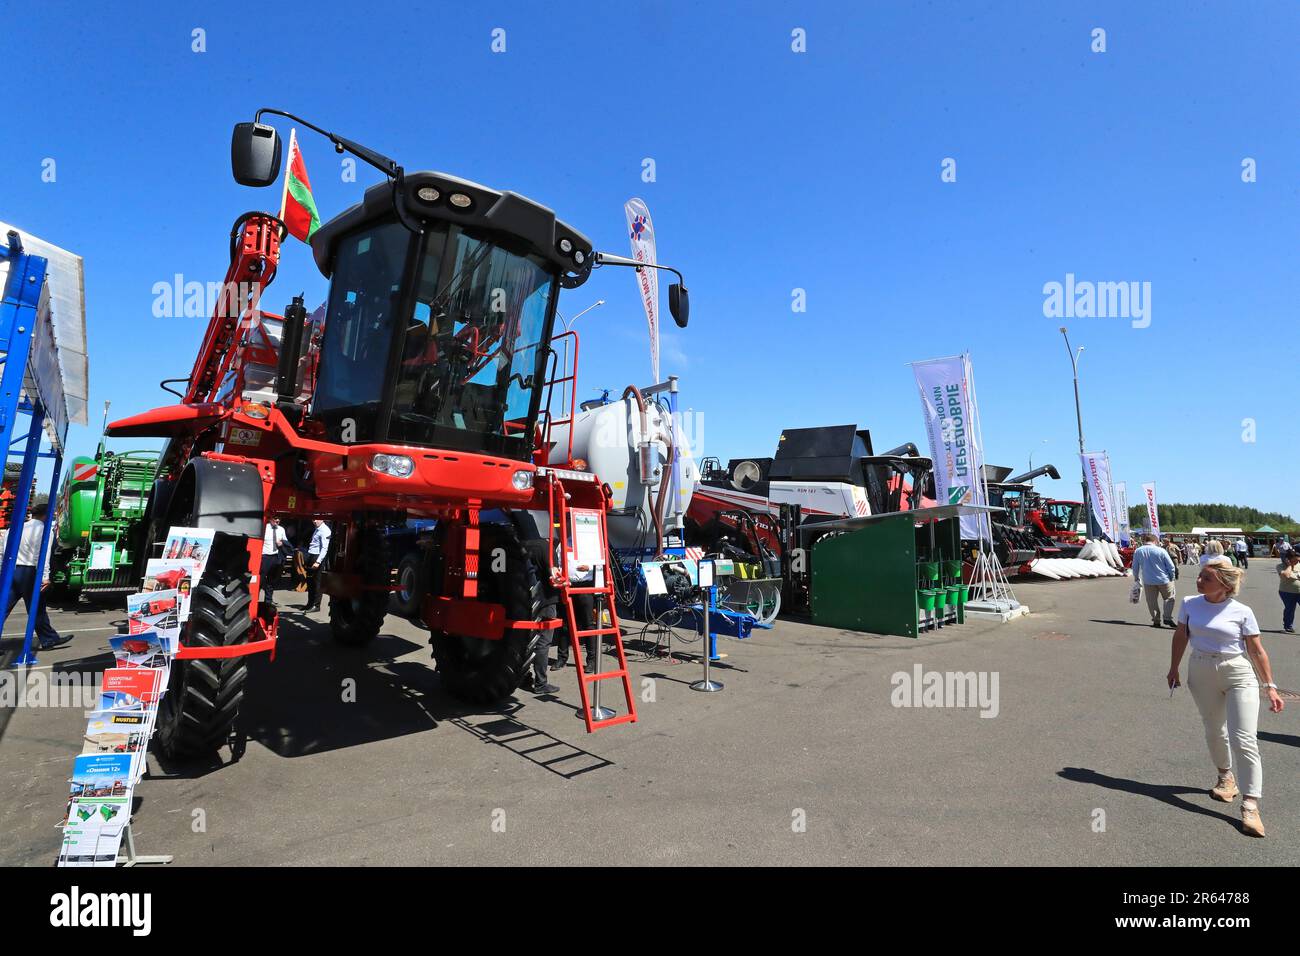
[1167, 555, 1283, 836]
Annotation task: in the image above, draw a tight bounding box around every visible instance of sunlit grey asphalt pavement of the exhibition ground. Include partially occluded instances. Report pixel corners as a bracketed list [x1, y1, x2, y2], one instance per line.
[0, 559, 1300, 866]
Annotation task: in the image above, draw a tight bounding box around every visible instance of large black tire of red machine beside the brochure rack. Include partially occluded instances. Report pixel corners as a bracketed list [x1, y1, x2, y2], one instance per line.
[157, 540, 252, 758]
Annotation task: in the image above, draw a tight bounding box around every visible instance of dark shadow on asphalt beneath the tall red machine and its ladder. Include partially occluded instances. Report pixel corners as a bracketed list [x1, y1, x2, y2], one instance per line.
[159, 609, 612, 778]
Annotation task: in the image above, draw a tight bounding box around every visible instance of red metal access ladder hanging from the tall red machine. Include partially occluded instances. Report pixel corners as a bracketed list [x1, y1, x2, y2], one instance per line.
[547, 470, 637, 734]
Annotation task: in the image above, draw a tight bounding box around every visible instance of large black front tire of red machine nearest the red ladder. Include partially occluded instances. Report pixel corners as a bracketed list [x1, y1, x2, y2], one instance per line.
[429, 524, 555, 706]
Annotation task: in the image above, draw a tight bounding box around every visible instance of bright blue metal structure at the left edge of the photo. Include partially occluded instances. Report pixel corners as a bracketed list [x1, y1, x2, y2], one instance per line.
[0, 230, 68, 667]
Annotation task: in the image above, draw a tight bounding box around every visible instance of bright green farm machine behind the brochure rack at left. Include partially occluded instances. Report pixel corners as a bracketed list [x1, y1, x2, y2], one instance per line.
[49, 442, 159, 597]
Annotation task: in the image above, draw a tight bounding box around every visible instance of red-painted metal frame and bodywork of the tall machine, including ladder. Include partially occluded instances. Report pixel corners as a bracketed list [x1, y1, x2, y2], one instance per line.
[109, 215, 637, 731]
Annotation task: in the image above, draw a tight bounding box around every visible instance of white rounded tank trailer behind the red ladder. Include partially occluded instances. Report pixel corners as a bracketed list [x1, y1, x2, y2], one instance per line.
[547, 389, 699, 548]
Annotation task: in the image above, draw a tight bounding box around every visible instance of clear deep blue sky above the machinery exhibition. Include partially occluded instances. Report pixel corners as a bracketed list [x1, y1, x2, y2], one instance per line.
[0, 3, 1300, 515]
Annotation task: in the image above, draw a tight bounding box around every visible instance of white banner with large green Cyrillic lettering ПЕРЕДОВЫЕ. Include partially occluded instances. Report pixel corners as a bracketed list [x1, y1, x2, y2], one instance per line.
[911, 354, 988, 540]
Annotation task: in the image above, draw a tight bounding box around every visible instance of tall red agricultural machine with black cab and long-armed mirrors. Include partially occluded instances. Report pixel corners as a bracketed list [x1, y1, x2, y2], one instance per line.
[109, 109, 689, 754]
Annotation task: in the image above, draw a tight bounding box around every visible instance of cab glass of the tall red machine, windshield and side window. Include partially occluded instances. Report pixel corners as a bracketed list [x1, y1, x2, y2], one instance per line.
[315, 222, 558, 459]
